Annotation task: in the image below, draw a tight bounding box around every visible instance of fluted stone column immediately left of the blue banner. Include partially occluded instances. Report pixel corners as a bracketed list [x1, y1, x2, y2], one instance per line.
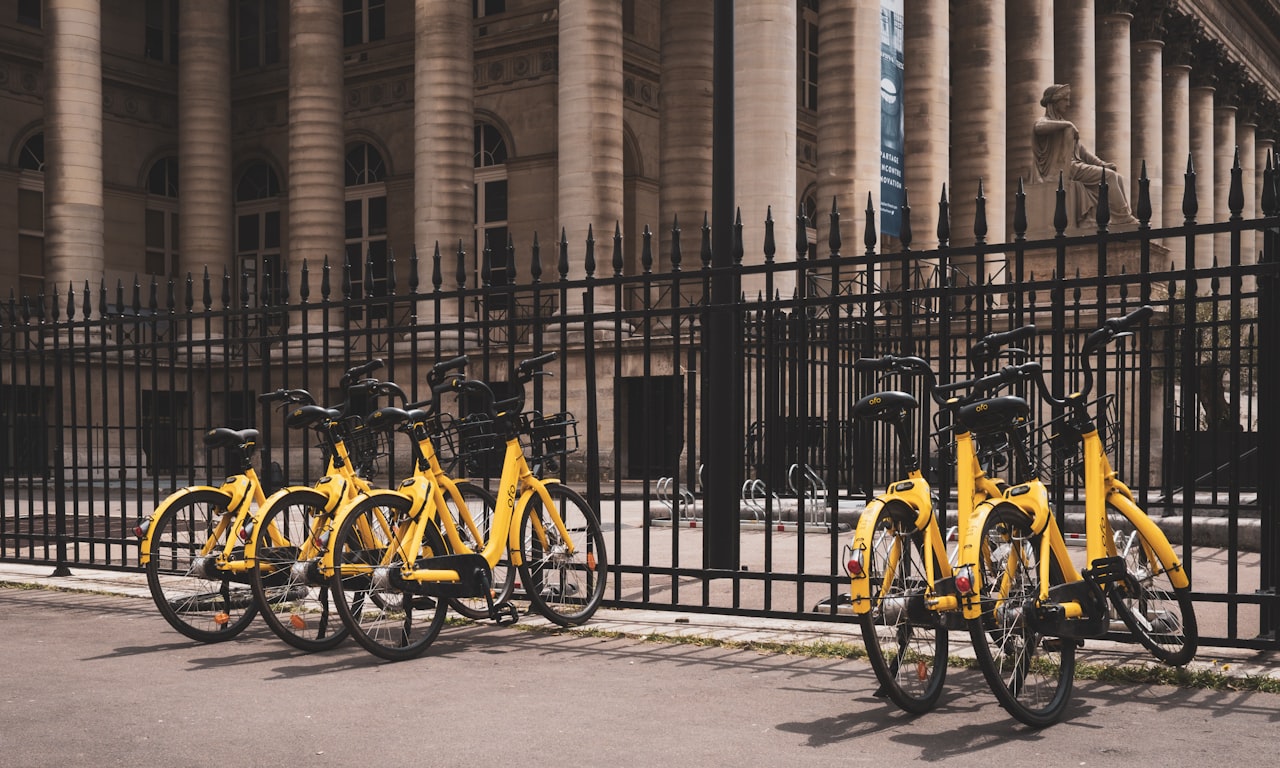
[814, 0, 881, 255]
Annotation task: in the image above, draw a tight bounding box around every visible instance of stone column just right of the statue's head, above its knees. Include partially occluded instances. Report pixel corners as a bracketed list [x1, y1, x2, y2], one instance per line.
[1090, 13, 1134, 189]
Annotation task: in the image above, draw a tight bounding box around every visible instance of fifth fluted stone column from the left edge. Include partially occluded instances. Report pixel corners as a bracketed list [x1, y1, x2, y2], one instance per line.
[557, 0, 622, 310]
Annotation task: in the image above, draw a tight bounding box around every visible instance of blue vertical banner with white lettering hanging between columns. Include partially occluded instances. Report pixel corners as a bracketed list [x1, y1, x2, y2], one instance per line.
[881, 0, 906, 237]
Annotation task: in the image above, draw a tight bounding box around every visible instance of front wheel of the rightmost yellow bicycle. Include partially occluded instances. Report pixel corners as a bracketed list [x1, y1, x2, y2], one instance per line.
[1107, 504, 1199, 667]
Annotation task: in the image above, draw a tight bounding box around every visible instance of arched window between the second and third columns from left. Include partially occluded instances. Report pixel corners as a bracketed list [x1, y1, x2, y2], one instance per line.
[234, 161, 284, 307]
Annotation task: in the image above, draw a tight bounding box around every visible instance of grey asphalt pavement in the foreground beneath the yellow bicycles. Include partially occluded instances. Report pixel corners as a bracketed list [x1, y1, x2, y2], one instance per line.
[0, 588, 1280, 768]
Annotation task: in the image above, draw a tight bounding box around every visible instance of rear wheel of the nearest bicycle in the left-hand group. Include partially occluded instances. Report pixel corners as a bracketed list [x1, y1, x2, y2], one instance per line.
[332, 494, 448, 662]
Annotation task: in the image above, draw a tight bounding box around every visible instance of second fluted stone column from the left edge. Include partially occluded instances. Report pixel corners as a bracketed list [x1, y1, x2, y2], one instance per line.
[178, 0, 234, 294]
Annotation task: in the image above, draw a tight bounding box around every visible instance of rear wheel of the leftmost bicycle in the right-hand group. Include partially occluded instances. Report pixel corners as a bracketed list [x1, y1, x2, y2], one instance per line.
[859, 502, 948, 714]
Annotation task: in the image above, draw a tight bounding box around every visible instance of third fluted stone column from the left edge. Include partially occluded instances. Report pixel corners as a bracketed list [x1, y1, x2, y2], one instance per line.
[288, 0, 346, 281]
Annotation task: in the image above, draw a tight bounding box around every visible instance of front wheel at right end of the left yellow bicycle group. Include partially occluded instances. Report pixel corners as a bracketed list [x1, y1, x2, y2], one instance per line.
[520, 483, 608, 627]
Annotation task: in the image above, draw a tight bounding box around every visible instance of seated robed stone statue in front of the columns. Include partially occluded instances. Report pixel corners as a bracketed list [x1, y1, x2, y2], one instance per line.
[1032, 83, 1137, 224]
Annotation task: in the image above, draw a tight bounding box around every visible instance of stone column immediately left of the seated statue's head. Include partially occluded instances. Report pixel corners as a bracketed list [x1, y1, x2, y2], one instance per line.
[1001, 0, 1054, 237]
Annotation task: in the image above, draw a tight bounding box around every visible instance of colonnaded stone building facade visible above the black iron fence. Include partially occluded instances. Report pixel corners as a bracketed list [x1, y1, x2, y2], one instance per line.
[0, 0, 1280, 308]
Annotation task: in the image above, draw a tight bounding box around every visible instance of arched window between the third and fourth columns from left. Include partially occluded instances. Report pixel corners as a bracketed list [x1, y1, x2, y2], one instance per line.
[346, 142, 388, 319]
